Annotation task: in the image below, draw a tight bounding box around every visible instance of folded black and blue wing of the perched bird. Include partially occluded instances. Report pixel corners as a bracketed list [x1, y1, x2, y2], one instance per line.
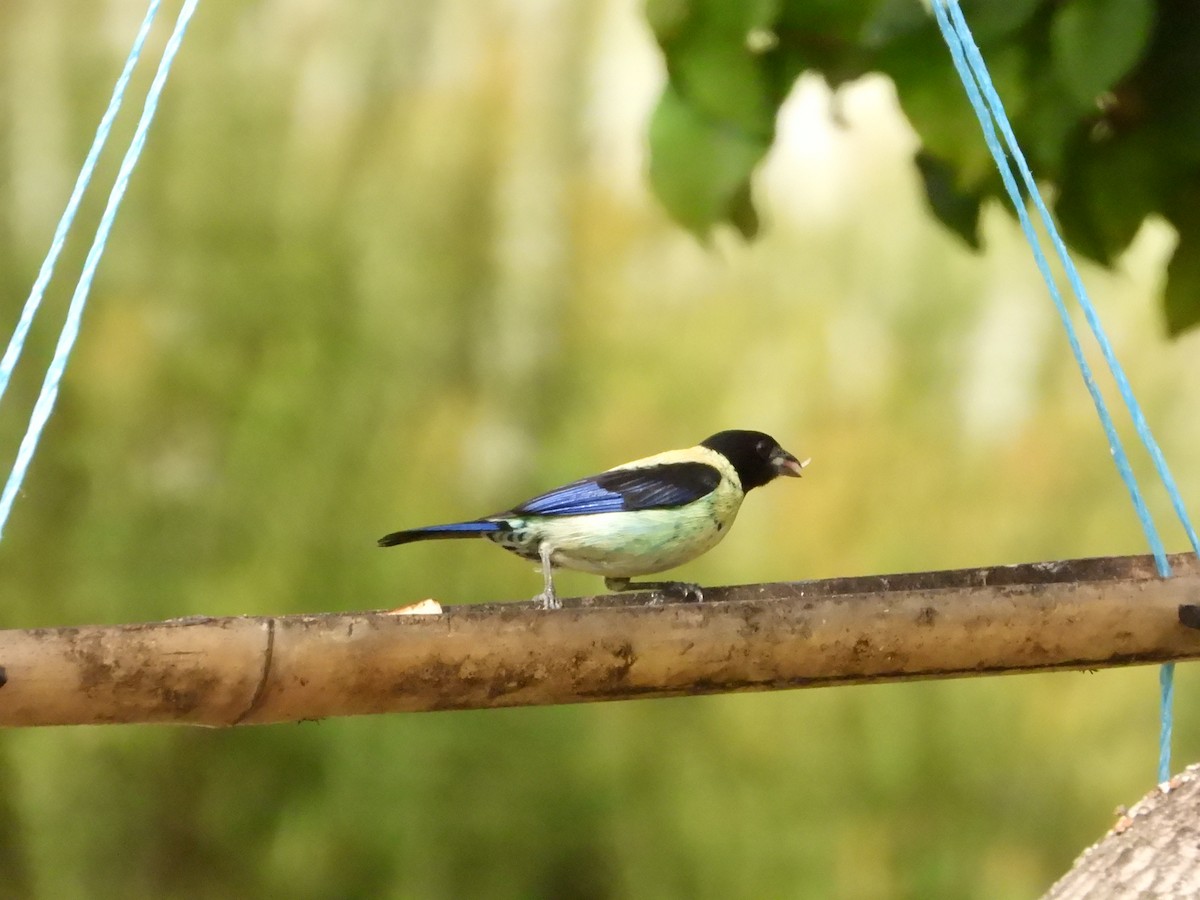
[505, 462, 721, 516]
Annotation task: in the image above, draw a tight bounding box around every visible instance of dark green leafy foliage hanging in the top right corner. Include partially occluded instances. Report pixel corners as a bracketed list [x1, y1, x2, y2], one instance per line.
[647, 0, 1200, 335]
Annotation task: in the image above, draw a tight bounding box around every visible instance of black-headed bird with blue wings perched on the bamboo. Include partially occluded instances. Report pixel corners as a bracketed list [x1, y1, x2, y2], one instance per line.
[378, 430, 810, 610]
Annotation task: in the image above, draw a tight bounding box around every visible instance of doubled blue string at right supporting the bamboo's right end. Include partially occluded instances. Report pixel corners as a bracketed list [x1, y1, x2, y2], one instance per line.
[932, 0, 1200, 781]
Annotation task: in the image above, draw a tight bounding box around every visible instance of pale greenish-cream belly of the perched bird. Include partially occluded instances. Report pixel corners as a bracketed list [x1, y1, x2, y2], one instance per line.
[493, 498, 737, 578]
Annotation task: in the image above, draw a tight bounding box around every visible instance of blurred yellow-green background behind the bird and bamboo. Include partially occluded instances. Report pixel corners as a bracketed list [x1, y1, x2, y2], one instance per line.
[0, 0, 1200, 898]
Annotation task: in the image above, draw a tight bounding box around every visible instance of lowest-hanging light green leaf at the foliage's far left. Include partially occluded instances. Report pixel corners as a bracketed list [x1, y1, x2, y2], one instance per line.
[649, 85, 770, 239]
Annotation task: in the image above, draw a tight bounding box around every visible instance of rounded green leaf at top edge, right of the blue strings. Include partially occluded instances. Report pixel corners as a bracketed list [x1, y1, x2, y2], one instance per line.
[1050, 0, 1154, 108]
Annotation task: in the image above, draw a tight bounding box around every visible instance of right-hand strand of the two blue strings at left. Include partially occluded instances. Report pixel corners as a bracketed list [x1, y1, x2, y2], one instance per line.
[0, 0, 199, 536]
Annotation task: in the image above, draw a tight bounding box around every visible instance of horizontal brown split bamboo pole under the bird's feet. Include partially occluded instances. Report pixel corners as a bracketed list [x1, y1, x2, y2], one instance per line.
[0, 554, 1200, 726]
